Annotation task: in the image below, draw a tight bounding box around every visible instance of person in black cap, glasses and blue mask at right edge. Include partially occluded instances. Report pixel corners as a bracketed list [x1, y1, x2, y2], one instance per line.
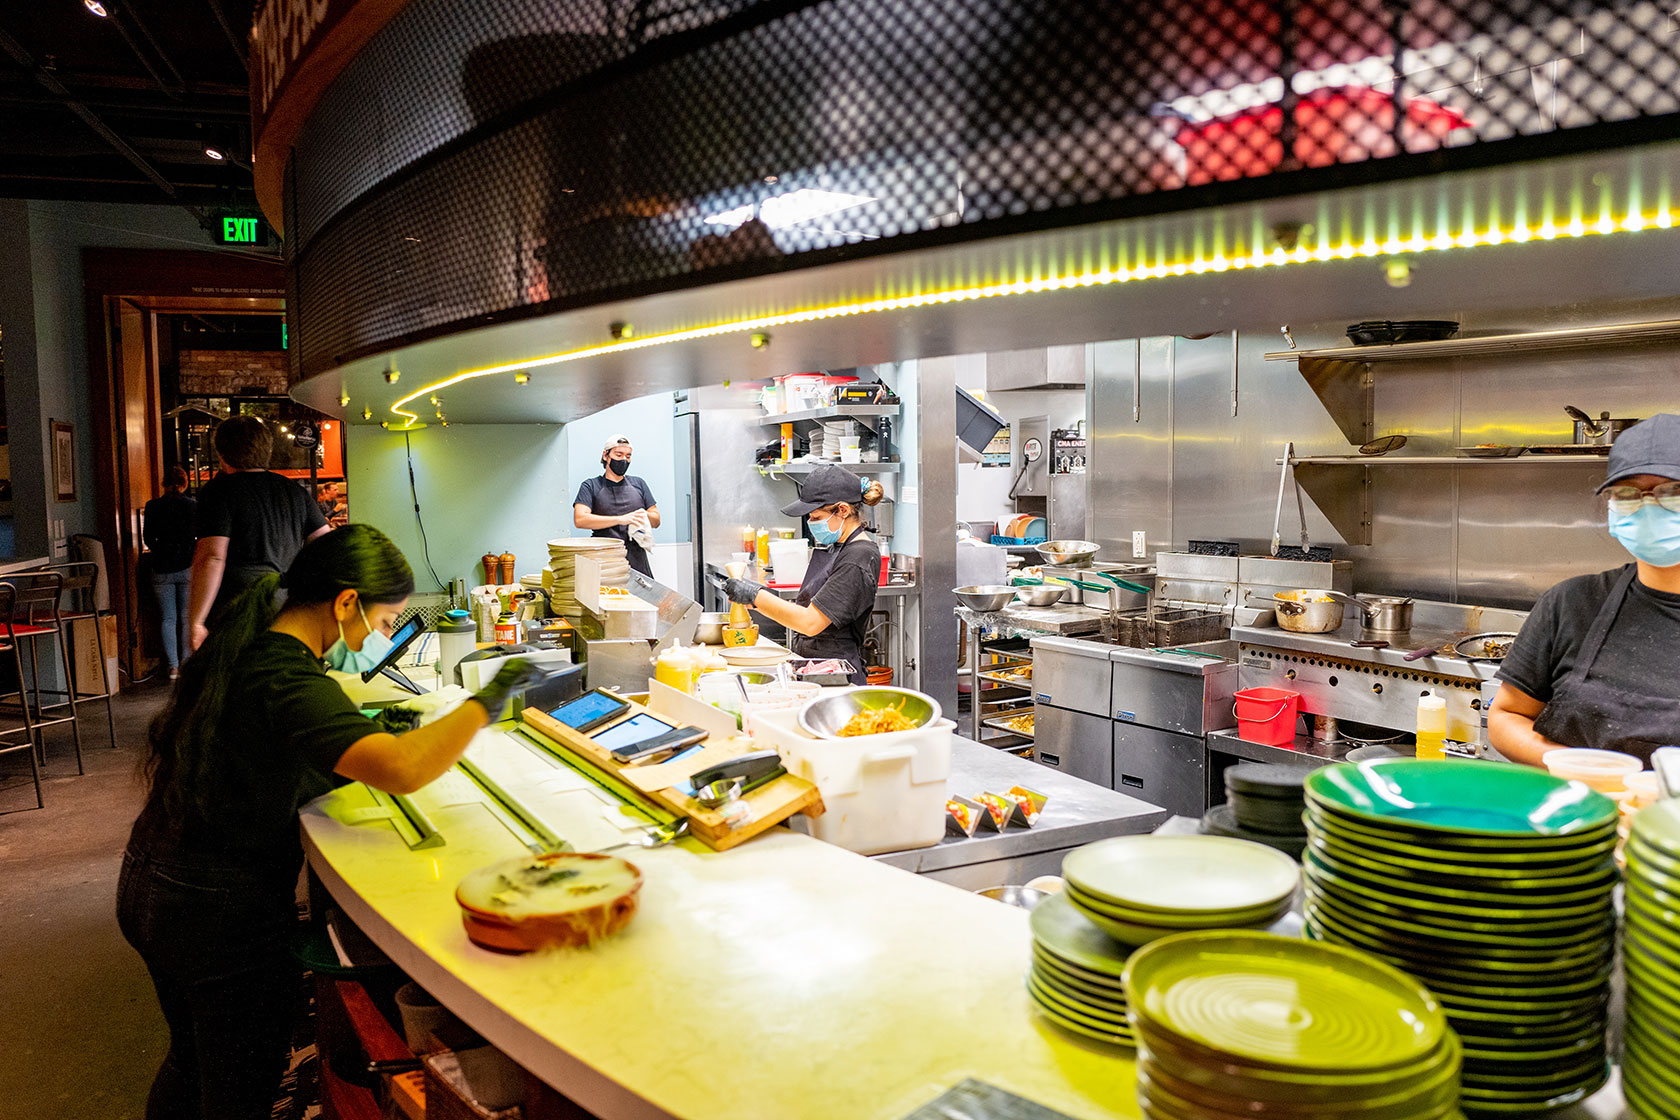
[1487, 413, 1680, 766]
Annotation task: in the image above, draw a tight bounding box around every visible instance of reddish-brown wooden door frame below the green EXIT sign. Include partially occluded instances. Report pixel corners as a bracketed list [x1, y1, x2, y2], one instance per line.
[82, 249, 286, 680]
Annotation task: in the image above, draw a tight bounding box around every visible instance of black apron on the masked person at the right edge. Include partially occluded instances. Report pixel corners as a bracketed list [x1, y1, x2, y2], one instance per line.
[1534, 564, 1680, 762]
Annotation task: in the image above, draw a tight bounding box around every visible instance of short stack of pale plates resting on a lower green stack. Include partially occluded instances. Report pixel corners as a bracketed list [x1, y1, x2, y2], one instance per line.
[1062, 836, 1300, 945]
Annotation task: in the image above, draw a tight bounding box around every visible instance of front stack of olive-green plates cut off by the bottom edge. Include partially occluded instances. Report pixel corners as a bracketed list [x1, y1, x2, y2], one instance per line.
[1126, 932, 1460, 1120]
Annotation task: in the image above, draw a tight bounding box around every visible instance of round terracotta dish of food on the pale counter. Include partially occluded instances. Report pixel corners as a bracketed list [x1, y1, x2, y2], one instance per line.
[455, 851, 642, 952]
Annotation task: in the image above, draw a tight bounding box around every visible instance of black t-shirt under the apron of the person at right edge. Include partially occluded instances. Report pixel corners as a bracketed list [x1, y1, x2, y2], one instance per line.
[1499, 568, 1680, 704]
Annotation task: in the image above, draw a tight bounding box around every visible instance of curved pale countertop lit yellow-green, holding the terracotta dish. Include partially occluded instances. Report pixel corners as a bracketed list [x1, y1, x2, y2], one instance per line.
[302, 724, 1164, 1120]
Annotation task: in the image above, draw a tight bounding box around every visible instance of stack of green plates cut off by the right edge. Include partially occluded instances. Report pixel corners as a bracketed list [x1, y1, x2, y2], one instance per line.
[1621, 801, 1680, 1117]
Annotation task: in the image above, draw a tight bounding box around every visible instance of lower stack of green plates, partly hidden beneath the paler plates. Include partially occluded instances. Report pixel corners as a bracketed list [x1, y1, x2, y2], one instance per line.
[1026, 895, 1132, 1046]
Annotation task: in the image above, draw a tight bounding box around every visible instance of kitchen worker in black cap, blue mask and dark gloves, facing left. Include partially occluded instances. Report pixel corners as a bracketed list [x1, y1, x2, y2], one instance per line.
[724, 467, 882, 685]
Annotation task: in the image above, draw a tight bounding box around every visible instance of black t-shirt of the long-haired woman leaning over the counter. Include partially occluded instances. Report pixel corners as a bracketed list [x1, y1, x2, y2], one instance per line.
[129, 630, 380, 877]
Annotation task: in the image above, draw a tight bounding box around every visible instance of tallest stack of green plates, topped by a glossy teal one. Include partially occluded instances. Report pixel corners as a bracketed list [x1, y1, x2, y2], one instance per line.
[1302, 759, 1616, 1115]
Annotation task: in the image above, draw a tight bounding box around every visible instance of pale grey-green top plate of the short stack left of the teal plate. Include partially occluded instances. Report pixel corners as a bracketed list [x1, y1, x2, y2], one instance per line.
[1062, 836, 1300, 917]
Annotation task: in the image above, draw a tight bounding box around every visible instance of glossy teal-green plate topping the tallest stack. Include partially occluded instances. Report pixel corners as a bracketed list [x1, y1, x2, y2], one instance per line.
[1305, 759, 1616, 838]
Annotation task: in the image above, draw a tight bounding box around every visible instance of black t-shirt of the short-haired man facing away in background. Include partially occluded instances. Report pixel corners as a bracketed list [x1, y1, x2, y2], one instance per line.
[198, 470, 326, 606]
